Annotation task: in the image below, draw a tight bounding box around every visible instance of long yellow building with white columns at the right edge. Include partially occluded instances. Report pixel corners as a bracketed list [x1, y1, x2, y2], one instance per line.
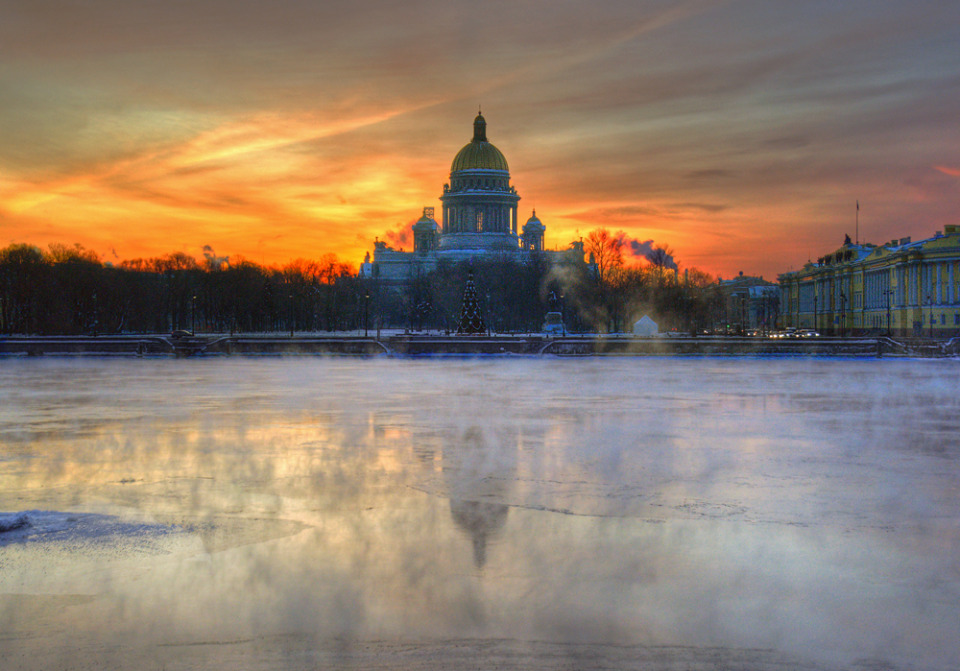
[778, 226, 960, 338]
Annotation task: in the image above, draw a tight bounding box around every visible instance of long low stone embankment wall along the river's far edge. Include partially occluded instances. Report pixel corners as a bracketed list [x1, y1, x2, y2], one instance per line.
[0, 334, 960, 357]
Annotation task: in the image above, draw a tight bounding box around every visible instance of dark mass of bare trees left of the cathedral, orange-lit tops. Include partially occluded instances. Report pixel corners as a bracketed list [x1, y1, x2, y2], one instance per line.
[0, 244, 360, 335]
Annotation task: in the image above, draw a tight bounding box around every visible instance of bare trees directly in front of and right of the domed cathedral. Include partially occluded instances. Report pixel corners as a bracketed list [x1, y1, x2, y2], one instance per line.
[372, 240, 725, 334]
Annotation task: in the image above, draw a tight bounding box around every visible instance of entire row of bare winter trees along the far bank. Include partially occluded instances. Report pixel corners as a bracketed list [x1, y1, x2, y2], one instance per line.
[0, 229, 723, 335]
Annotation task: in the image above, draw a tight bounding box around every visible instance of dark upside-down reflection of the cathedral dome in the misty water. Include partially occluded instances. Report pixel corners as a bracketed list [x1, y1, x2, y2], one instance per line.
[443, 426, 517, 568]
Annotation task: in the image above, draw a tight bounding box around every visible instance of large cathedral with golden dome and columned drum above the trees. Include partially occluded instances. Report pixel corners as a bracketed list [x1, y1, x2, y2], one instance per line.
[360, 114, 583, 284]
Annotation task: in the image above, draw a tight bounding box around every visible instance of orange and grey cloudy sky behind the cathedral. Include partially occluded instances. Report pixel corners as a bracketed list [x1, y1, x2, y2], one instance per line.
[0, 0, 960, 279]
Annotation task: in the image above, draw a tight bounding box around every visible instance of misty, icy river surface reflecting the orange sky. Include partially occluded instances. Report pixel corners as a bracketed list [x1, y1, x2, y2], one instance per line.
[0, 357, 960, 671]
